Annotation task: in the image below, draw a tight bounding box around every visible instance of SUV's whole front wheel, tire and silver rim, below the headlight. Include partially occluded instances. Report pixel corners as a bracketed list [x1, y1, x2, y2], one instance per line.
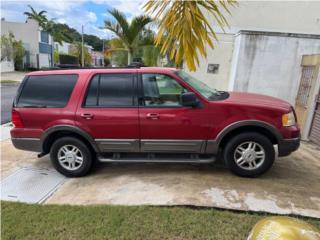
[223, 132, 275, 177]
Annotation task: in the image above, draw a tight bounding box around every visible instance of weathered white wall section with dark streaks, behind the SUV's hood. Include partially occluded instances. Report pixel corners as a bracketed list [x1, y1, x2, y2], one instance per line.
[229, 33, 320, 105]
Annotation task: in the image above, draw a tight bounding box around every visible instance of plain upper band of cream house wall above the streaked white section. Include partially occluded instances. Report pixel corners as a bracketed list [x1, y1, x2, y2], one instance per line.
[209, 1, 320, 34]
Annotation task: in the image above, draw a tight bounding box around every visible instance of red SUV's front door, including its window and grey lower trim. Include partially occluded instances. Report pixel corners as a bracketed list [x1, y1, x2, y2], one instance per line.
[139, 73, 209, 153]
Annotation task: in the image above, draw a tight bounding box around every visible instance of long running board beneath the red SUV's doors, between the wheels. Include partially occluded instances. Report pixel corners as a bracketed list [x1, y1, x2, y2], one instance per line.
[97, 156, 216, 163]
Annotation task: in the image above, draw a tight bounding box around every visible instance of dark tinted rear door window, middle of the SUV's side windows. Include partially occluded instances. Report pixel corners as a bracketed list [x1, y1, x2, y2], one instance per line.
[84, 73, 134, 107]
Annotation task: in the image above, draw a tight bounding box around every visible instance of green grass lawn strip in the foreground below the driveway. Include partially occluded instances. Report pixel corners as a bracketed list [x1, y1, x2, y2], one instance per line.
[1, 202, 320, 240]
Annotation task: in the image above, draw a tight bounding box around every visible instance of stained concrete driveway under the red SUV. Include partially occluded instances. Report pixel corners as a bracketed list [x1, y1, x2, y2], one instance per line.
[1, 141, 320, 218]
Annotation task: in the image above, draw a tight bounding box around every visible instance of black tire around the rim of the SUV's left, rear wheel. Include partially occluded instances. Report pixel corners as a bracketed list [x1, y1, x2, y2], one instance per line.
[50, 137, 93, 177]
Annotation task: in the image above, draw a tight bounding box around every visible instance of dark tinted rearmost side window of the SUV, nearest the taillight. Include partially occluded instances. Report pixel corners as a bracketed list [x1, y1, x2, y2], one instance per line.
[17, 74, 78, 108]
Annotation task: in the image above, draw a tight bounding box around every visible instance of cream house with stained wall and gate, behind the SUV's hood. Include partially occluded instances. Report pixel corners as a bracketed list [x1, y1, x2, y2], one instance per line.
[186, 1, 320, 143]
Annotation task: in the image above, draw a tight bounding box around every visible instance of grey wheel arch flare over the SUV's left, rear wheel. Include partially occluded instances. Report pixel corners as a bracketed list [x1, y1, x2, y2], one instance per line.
[40, 125, 99, 153]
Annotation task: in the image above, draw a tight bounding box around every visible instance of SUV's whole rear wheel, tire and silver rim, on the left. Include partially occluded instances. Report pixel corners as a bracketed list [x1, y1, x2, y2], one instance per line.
[50, 137, 92, 177]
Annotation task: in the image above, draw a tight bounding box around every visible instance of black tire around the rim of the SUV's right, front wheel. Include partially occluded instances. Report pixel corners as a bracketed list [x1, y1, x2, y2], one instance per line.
[223, 132, 275, 177]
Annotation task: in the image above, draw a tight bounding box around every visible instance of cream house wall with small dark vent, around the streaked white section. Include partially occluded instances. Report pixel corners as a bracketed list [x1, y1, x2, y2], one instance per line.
[185, 1, 320, 90]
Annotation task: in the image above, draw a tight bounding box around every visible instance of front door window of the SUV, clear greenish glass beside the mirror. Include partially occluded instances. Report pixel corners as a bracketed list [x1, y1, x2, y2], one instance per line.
[142, 73, 188, 107]
